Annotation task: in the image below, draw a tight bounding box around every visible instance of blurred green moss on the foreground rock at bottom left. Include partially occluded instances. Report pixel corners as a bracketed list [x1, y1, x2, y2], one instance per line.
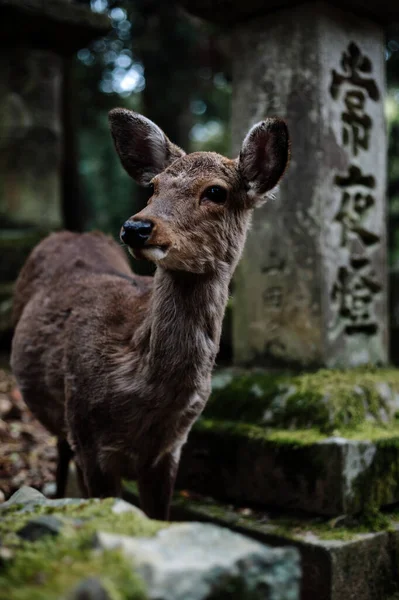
[0, 499, 167, 600]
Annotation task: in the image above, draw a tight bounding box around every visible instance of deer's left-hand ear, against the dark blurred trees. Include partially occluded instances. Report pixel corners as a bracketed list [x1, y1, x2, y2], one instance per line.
[109, 108, 185, 185]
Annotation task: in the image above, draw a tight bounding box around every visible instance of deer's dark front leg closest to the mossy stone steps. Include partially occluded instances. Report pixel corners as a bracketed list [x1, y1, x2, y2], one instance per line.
[137, 450, 180, 521]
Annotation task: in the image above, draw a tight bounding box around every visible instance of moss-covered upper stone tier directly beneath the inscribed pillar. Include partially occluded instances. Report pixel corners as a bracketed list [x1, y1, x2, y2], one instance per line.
[205, 367, 399, 434]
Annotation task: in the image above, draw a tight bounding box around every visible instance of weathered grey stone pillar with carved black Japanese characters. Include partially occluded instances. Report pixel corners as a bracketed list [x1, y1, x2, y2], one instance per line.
[232, 3, 388, 367]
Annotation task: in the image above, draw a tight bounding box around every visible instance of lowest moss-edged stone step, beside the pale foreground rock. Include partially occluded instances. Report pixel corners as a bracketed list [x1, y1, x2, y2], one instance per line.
[121, 483, 399, 600]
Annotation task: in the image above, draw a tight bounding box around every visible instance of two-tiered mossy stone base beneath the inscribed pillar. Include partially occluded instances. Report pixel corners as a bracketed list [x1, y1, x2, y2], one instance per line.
[178, 368, 399, 516]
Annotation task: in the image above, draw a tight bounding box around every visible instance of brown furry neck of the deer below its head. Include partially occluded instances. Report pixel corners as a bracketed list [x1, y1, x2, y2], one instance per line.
[137, 263, 231, 388]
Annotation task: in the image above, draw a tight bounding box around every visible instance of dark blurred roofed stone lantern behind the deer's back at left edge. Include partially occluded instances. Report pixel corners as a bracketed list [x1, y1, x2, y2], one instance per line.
[0, 0, 110, 332]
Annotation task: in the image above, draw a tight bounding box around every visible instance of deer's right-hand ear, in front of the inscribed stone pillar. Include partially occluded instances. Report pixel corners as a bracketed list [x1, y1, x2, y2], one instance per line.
[238, 119, 290, 204]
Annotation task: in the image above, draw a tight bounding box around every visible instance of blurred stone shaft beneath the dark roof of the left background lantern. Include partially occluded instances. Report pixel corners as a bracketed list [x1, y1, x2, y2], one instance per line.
[0, 48, 62, 230]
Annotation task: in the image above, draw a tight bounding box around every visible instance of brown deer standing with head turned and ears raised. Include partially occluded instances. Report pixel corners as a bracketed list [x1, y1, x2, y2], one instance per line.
[11, 108, 290, 520]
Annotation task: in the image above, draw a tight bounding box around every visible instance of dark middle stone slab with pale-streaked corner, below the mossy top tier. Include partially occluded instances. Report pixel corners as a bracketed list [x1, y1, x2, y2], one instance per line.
[178, 420, 399, 516]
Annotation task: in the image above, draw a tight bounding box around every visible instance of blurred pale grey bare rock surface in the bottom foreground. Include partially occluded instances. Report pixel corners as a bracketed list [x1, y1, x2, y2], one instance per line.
[96, 523, 300, 600]
